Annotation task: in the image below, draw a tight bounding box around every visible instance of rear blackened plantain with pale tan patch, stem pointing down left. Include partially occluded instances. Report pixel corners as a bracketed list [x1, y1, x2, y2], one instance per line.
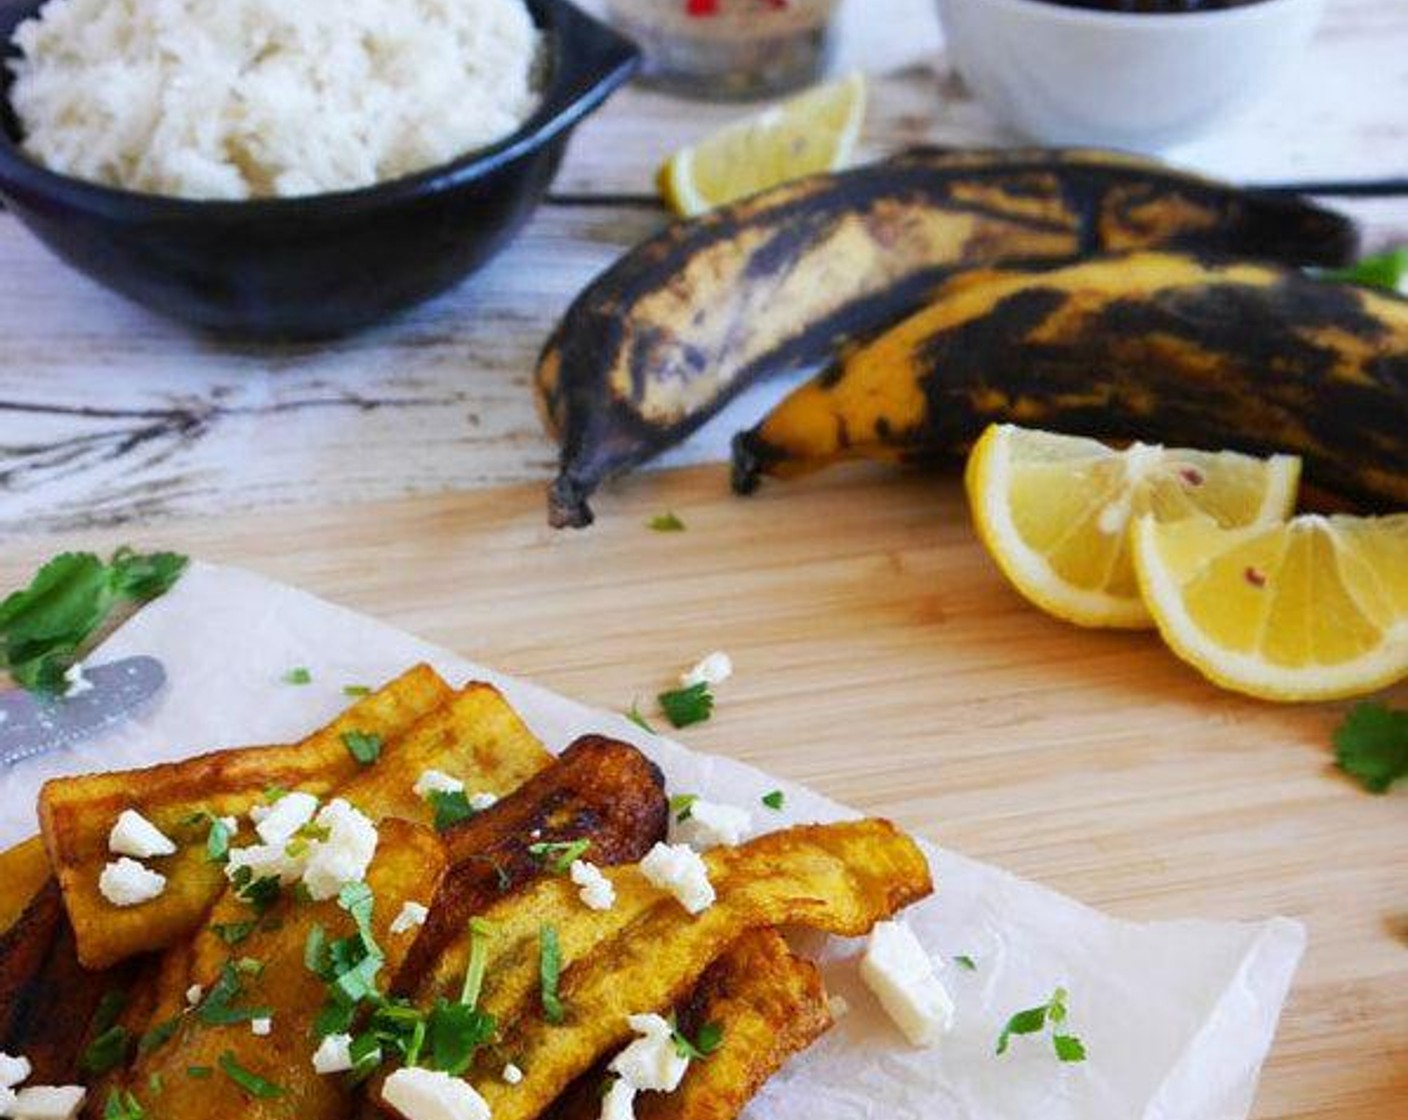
[536, 149, 1356, 527]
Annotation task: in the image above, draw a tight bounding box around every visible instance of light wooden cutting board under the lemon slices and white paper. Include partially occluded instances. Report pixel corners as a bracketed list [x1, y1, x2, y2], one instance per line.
[0, 468, 1408, 1120]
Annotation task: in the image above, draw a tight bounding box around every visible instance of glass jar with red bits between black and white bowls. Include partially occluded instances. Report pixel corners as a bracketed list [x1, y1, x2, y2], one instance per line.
[607, 0, 839, 100]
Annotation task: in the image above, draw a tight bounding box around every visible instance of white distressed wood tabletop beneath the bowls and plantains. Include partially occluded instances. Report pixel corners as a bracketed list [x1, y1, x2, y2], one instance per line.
[0, 0, 1408, 534]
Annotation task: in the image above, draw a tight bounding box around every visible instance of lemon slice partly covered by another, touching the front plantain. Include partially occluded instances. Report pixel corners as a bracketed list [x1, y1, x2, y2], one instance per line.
[966, 424, 1301, 630]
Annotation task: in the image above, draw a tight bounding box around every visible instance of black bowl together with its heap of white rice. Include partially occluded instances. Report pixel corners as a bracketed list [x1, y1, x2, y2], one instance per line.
[0, 0, 638, 337]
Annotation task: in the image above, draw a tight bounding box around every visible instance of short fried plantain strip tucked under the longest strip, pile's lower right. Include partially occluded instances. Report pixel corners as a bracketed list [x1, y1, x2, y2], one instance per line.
[545, 928, 832, 1120]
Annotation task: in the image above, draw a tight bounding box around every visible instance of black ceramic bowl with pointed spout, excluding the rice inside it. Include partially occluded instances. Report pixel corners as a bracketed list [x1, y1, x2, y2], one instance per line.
[0, 0, 639, 338]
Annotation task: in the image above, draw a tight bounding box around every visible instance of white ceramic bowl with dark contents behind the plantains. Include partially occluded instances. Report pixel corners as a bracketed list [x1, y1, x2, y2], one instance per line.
[938, 0, 1323, 152]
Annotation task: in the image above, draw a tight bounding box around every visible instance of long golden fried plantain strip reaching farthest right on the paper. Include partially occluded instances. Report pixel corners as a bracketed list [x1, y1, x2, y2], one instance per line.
[388, 820, 934, 1120]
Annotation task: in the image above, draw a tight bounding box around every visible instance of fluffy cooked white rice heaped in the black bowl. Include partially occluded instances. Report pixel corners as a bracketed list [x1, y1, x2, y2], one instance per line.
[10, 0, 539, 199]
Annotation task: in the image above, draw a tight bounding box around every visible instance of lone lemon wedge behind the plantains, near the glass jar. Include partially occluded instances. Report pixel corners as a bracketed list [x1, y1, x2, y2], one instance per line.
[658, 73, 866, 217]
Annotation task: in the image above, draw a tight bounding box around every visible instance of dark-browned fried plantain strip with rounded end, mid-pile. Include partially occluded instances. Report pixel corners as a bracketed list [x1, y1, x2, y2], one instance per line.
[397, 735, 669, 992]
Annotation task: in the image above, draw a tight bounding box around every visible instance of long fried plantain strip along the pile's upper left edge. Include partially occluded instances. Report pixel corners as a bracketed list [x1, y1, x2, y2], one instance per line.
[39, 665, 451, 968]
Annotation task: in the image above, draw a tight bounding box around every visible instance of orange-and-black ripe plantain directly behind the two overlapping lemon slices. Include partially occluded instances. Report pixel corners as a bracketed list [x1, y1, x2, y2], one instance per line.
[734, 252, 1408, 509]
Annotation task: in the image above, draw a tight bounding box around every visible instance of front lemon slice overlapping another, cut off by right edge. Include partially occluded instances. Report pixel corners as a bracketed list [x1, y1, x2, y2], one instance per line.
[1133, 514, 1408, 700]
